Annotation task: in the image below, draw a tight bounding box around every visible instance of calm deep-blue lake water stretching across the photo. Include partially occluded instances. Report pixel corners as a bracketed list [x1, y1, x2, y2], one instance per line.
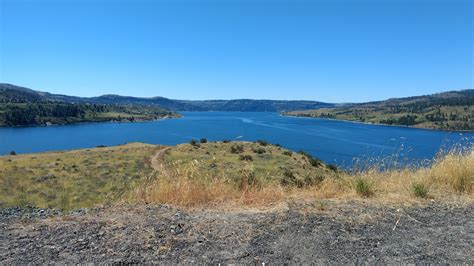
[0, 112, 474, 167]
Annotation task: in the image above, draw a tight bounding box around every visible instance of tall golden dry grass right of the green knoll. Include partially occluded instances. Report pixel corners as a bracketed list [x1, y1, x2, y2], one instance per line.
[315, 149, 474, 201]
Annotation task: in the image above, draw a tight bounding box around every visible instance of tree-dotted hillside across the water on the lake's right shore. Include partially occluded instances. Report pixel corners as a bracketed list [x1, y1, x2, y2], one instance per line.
[285, 89, 474, 131]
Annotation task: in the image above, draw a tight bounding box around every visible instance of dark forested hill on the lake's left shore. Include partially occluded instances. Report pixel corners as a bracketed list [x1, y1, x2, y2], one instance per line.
[0, 84, 177, 126]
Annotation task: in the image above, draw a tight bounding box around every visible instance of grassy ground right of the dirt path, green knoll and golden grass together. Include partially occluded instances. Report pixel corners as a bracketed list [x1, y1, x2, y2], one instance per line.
[139, 142, 474, 206]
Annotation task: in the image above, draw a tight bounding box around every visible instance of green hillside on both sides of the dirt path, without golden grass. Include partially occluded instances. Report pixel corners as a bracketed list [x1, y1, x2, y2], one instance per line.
[0, 142, 335, 209]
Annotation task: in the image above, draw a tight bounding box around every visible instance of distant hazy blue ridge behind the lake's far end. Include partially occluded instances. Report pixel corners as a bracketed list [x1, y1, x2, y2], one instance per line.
[0, 84, 334, 112]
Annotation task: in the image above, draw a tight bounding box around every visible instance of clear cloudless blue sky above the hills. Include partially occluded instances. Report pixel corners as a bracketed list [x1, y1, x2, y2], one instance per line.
[0, 0, 474, 102]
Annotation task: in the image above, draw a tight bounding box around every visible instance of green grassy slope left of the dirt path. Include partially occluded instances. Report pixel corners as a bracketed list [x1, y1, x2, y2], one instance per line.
[0, 143, 159, 209]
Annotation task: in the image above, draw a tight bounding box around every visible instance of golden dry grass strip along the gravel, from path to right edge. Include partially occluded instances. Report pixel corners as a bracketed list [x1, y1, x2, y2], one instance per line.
[135, 142, 474, 207]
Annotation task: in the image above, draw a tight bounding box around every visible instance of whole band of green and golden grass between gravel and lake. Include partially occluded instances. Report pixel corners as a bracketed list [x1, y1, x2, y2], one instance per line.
[0, 138, 474, 211]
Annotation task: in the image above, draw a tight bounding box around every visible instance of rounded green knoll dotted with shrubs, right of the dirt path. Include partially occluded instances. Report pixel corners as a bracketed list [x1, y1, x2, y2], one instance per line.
[165, 142, 335, 186]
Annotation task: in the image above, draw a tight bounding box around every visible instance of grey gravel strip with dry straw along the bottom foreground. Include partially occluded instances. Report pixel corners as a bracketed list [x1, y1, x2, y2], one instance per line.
[0, 201, 474, 264]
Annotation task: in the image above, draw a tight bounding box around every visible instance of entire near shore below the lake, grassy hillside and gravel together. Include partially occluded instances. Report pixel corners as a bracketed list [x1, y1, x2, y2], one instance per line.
[0, 139, 474, 264]
